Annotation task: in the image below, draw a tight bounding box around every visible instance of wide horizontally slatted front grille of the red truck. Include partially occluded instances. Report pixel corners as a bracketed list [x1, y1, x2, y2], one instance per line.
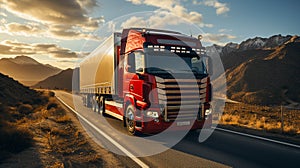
[156, 77, 207, 121]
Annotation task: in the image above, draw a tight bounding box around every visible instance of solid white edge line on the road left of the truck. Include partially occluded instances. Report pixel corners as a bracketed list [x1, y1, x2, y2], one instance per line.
[55, 96, 149, 168]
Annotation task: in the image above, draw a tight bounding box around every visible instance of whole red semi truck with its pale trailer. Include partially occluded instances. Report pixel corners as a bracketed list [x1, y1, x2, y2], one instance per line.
[80, 28, 212, 134]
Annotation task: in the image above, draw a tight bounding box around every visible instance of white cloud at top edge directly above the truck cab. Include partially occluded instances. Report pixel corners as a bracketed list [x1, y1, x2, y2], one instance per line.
[127, 0, 203, 25]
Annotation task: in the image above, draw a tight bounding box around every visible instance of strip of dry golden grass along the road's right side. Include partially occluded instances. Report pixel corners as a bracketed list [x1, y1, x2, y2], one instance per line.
[220, 103, 300, 136]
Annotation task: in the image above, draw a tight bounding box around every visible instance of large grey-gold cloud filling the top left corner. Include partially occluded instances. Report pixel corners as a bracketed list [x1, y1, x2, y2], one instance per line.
[2, 0, 97, 28]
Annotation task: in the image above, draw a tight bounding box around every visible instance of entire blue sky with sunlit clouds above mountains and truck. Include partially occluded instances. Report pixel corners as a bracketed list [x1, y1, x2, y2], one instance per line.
[0, 0, 300, 69]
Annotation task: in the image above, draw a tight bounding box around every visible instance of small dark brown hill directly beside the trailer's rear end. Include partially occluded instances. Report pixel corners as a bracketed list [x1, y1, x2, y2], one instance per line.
[32, 68, 74, 91]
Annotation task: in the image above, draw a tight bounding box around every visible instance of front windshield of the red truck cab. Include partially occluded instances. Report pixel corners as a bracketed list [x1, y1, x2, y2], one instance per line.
[146, 53, 207, 74]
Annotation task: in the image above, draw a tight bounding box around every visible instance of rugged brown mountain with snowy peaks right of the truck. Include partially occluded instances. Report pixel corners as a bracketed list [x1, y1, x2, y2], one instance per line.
[207, 35, 300, 105]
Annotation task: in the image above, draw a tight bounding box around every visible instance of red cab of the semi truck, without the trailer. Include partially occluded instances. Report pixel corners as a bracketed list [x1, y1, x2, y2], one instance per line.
[120, 29, 211, 134]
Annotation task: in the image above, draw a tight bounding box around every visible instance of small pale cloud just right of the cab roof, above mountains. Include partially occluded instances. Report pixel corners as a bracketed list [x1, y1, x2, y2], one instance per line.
[202, 33, 236, 46]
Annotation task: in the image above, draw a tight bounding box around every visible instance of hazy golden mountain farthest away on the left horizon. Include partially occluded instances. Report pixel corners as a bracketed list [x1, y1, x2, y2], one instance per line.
[0, 56, 61, 86]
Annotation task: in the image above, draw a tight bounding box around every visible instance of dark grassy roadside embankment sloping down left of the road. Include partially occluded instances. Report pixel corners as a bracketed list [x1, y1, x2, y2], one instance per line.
[0, 74, 123, 167]
